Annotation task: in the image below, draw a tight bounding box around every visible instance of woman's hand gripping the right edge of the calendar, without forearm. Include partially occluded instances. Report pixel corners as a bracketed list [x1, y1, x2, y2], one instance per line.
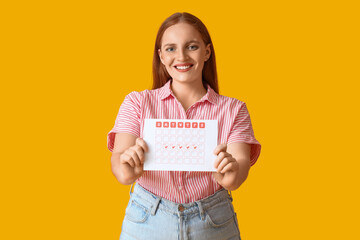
[213, 144, 240, 189]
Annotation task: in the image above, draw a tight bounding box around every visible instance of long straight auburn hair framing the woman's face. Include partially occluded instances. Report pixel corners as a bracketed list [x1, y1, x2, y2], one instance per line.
[152, 12, 219, 93]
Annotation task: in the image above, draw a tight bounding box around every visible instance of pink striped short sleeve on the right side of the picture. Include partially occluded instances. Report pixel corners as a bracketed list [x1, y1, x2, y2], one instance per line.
[227, 102, 261, 166]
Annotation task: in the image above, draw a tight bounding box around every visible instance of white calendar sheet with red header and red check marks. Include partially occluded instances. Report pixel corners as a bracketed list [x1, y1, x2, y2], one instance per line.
[143, 119, 218, 171]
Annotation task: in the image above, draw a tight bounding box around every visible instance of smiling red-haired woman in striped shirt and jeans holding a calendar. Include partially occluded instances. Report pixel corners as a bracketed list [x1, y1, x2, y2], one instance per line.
[108, 12, 261, 240]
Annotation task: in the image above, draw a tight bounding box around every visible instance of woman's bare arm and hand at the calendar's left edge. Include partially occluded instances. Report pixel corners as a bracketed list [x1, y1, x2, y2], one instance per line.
[111, 133, 148, 185]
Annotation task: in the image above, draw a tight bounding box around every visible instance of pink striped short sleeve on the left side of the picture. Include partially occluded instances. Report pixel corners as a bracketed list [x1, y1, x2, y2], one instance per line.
[107, 92, 140, 152]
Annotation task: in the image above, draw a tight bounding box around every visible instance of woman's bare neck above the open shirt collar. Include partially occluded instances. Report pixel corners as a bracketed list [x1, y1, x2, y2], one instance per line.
[171, 81, 207, 111]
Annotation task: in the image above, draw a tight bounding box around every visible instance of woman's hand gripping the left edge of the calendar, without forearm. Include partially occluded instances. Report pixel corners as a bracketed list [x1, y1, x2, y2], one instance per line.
[120, 138, 148, 178]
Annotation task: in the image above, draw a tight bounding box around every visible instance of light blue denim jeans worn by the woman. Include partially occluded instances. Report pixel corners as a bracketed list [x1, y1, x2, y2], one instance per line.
[120, 184, 241, 240]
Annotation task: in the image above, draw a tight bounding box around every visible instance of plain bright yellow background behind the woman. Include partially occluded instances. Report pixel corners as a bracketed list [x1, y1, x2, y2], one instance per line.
[0, 0, 360, 240]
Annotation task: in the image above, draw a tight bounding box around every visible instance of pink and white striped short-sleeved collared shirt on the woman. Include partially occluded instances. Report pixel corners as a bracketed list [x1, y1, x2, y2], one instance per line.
[107, 80, 261, 203]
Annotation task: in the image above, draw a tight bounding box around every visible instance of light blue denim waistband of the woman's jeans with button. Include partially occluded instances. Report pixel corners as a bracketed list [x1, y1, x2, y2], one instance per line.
[130, 183, 232, 218]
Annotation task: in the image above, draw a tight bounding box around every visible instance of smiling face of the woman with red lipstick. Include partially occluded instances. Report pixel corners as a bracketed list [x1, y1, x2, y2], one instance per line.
[158, 23, 211, 83]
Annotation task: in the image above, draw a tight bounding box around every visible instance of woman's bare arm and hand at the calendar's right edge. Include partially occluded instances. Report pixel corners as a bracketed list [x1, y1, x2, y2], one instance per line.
[213, 142, 251, 191]
